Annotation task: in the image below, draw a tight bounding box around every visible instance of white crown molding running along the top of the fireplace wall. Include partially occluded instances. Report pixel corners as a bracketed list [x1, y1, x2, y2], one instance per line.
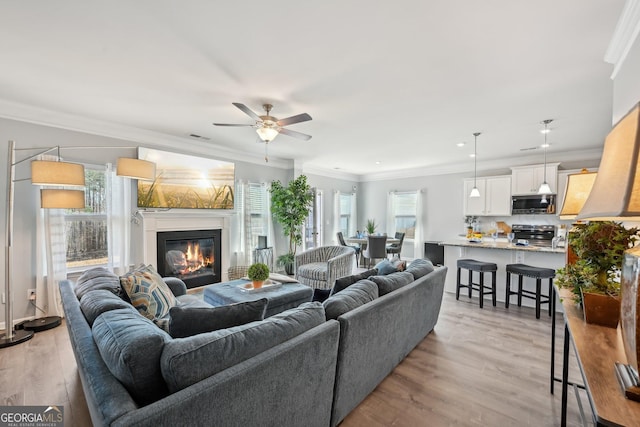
[0, 99, 293, 169]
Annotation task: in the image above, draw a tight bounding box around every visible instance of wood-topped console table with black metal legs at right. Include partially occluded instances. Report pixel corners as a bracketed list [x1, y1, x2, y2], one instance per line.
[551, 289, 640, 427]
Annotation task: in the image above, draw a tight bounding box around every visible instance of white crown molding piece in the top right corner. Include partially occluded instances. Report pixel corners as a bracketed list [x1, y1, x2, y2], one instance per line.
[604, 0, 640, 80]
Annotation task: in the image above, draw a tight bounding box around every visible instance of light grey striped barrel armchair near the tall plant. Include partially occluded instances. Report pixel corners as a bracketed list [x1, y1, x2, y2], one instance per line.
[295, 246, 356, 289]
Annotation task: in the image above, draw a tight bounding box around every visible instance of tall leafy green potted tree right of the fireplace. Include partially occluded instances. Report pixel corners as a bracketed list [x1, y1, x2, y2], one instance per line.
[270, 175, 313, 275]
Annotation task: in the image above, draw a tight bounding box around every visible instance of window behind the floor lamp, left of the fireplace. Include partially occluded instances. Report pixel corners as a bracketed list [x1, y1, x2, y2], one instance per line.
[65, 167, 108, 270]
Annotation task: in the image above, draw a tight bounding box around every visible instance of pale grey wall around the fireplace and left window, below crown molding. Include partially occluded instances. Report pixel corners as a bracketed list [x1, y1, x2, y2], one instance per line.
[0, 119, 293, 323]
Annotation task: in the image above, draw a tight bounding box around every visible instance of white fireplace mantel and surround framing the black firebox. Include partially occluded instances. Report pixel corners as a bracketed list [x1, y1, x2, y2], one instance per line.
[136, 210, 231, 281]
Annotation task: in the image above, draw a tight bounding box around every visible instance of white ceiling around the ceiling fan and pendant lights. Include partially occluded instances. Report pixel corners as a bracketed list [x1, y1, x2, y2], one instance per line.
[0, 0, 624, 175]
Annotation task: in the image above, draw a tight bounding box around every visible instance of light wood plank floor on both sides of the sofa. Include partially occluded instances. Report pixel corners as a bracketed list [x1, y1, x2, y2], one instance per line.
[0, 294, 588, 427]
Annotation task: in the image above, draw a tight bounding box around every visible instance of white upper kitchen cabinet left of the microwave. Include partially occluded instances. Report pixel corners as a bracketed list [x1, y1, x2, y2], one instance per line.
[463, 176, 511, 216]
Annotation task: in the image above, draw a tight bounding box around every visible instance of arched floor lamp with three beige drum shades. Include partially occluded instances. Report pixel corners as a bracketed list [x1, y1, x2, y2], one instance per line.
[0, 141, 155, 348]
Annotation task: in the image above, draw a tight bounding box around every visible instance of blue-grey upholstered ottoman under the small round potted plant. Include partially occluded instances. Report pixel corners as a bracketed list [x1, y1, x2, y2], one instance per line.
[204, 279, 313, 317]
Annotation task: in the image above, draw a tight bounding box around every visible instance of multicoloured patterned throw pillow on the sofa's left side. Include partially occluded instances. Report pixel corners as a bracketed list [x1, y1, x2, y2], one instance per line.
[120, 265, 177, 321]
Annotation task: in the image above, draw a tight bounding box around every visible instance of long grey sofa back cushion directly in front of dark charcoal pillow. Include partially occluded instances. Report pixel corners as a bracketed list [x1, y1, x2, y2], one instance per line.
[160, 302, 325, 392]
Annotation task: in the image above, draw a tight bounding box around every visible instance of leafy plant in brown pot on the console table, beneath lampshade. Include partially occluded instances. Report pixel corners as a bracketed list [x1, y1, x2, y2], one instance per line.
[556, 221, 639, 327]
